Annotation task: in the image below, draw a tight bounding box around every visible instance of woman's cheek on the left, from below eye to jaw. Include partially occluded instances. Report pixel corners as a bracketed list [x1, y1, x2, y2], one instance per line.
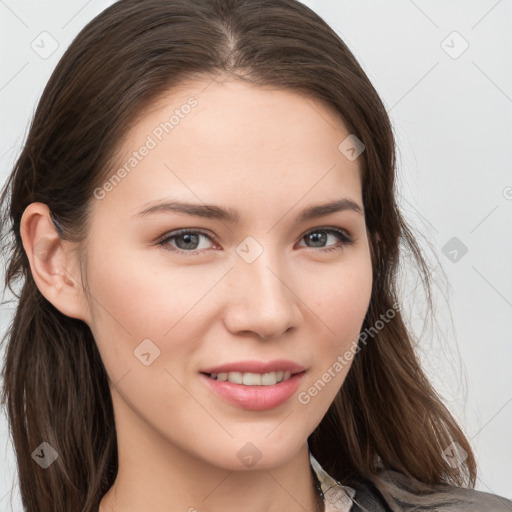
[82, 248, 218, 434]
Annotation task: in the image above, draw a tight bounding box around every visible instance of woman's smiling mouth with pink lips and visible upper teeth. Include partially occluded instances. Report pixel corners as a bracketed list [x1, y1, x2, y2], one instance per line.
[199, 361, 305, 411]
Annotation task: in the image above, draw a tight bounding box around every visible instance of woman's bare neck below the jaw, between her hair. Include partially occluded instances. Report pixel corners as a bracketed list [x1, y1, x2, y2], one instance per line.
[99, 394, 324, 512]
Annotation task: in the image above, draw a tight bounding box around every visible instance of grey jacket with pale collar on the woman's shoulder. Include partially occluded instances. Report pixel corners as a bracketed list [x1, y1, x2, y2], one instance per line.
[309, 452, 512, 512]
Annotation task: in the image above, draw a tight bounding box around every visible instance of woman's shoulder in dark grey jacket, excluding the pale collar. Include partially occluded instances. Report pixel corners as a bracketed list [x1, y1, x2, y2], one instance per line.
[352, 470, 512, 512]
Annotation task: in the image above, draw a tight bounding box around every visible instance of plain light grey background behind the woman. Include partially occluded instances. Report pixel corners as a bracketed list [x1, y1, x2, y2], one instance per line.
[0, 0, 512, 511]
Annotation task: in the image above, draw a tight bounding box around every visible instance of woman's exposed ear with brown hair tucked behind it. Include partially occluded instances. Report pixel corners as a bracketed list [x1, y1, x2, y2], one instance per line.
[20, 203, 90, 323]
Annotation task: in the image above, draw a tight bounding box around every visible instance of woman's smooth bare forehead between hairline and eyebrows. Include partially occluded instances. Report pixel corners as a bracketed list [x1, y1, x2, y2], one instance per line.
[95, 78, 361, 220]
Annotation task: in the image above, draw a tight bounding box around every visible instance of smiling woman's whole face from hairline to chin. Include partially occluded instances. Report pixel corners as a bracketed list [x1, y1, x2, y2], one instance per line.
[79, 79, 372, 469]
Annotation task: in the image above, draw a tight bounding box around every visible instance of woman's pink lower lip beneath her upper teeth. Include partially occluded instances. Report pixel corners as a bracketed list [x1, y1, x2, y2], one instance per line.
[200, 372, 305, 411]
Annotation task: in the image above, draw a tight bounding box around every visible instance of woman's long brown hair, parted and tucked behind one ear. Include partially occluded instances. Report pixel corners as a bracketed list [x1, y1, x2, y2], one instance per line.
[0, 0, 476, 512]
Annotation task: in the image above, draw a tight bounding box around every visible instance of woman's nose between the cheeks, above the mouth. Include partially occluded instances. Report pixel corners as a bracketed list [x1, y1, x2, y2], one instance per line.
[224, 251, 302, 339]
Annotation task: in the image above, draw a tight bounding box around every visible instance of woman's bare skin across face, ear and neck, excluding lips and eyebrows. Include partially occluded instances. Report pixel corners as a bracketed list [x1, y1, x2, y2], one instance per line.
[21, 79, 372, 512]
